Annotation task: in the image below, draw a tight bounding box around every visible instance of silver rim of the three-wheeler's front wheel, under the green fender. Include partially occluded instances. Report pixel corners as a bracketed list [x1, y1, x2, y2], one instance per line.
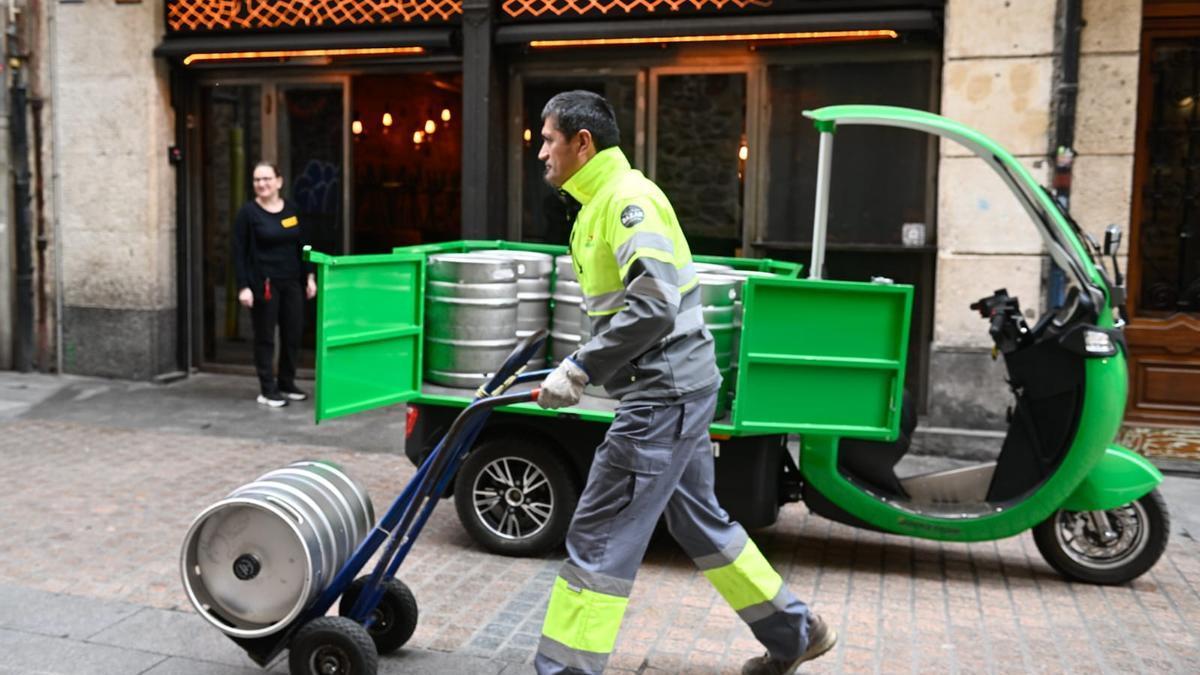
[1054, 501, 1150, 569]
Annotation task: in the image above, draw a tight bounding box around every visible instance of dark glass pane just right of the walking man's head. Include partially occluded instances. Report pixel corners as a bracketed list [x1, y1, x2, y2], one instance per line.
[654, 72, 746, 255]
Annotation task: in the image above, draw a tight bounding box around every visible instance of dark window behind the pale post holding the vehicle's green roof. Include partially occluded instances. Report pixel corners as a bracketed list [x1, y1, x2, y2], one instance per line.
[764, 60, 932, 245]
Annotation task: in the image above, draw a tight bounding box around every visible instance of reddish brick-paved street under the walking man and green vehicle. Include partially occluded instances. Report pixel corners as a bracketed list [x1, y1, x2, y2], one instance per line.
[0, 420, 1200, 674]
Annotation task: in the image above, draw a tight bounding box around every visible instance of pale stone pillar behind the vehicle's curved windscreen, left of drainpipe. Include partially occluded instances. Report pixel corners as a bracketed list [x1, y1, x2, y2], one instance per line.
[928, 0, 1056, 429]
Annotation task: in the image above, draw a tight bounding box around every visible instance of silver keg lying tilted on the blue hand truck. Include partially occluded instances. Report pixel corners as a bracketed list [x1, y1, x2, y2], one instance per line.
[180, 461, 374, 638]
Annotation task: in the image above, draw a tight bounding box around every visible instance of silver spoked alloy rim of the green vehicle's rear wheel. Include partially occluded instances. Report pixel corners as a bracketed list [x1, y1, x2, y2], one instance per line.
[472, 456, 554, 540]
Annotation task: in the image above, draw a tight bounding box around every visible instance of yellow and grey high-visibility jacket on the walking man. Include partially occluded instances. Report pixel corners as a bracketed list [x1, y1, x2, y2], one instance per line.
[563, 148, 721, 401]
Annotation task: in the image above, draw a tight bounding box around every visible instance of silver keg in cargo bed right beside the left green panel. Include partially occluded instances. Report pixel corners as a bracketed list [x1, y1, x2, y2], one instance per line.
[425, 253, 518, 388]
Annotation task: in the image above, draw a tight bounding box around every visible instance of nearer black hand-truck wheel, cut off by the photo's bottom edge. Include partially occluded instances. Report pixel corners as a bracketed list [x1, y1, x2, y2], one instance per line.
[288, 616, 379, 675]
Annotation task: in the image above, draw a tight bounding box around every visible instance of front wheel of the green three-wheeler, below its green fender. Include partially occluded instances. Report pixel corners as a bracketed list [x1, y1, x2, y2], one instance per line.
[1033, 482, 1171, 585]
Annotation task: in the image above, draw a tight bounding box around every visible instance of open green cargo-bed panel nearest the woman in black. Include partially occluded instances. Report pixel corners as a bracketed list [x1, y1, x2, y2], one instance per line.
[307, 251, 425, 422]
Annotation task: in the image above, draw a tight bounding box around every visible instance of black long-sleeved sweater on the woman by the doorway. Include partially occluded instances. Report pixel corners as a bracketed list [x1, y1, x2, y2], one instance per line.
[233, 199, 312, 288]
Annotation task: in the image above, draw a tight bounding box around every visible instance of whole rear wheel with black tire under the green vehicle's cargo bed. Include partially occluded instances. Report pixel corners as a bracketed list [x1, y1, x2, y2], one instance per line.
[454, 437, 580, 556]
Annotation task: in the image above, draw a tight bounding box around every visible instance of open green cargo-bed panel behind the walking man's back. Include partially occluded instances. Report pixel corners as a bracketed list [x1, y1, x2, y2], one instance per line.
[733, 277, 912, 440]
